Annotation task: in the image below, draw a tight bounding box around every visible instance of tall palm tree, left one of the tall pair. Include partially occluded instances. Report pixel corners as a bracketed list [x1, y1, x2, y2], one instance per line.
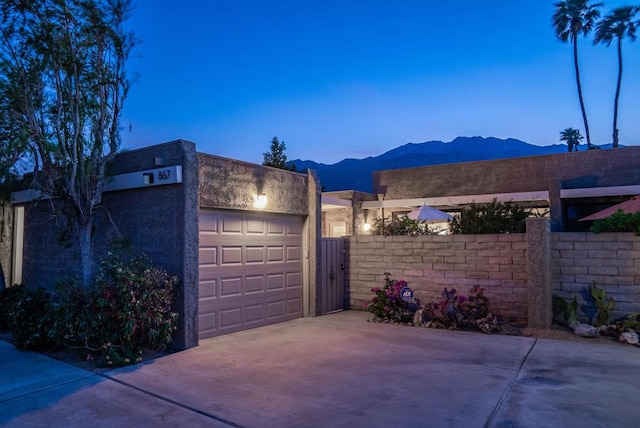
[552, 0, 602, 149]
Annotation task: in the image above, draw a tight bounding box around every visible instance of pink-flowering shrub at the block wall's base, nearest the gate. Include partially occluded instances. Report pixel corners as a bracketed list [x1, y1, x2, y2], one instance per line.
[364, 272, 419, 323]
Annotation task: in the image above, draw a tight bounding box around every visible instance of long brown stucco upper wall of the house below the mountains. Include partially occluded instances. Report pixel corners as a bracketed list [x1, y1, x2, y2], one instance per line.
[373, 147, 640, 199]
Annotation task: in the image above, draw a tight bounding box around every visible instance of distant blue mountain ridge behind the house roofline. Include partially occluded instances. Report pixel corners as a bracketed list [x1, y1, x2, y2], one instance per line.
[293, 137, 567, 192]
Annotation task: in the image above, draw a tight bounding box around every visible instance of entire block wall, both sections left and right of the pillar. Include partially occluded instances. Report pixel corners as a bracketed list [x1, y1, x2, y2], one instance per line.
[345, 233, 640, 324]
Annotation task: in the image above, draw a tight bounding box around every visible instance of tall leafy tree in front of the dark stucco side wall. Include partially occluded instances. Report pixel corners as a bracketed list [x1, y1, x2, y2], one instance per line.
[0, 0, 136, 284]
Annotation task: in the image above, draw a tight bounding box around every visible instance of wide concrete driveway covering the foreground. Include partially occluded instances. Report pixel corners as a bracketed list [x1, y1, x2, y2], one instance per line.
[0, 311, 640, 428]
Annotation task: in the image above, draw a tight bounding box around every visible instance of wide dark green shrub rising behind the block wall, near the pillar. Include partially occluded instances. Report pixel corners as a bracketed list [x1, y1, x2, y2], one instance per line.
[449, 199, 534, 234]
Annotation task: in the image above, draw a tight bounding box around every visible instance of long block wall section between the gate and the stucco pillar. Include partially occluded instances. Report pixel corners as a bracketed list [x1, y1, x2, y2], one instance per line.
[345, 234, 527, 324]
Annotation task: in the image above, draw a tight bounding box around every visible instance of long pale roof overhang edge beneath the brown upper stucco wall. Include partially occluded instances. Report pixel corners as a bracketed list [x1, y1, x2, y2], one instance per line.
[362, 185, 640, 209]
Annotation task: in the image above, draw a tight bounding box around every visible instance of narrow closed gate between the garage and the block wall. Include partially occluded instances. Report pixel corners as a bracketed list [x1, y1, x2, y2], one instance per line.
[320, 238, 345, 314]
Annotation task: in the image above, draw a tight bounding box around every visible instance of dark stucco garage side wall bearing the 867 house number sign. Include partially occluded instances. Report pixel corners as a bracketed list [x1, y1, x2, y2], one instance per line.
[23, 141, 198, 347]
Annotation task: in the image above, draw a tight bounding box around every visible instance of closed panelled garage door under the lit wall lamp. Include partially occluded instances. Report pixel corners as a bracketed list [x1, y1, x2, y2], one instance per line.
[198, 210, 302, 339]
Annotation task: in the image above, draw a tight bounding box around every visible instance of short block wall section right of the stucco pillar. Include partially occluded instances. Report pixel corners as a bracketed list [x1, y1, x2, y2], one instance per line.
[551, 233, 640, 322]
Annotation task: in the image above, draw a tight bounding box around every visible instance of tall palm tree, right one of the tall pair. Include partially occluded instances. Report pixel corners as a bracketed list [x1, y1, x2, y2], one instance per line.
[593, 6, 640, 147]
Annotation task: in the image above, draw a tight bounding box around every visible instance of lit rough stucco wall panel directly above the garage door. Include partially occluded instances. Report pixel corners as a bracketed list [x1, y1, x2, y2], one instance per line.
[198, 153, 309, 215]
